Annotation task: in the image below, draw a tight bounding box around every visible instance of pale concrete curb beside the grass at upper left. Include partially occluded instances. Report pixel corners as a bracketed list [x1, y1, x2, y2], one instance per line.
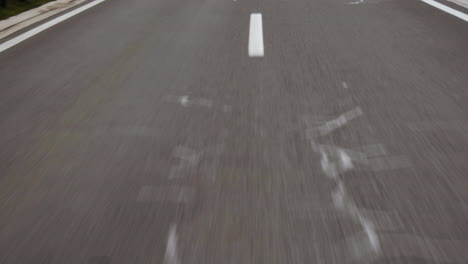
[0, 0, 86, 39]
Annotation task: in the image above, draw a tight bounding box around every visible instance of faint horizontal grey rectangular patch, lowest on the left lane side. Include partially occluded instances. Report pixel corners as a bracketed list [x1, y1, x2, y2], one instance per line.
[137, 185, 195, 204]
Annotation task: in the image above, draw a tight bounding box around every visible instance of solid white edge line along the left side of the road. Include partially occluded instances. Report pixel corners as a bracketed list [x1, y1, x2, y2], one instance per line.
[0, 0, 106, 53]
